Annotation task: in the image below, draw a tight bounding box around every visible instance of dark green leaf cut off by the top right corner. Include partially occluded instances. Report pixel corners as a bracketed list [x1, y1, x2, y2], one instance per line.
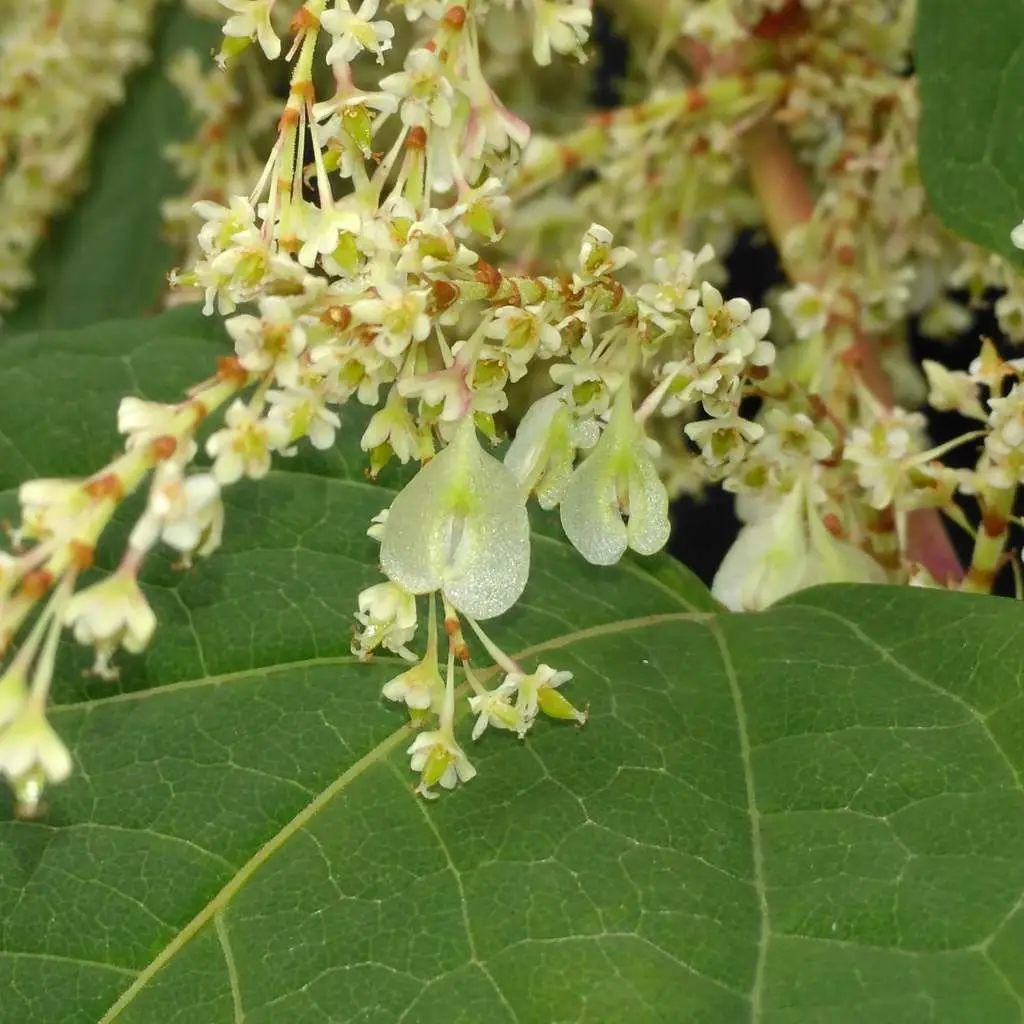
[914, 0, 1024, 262]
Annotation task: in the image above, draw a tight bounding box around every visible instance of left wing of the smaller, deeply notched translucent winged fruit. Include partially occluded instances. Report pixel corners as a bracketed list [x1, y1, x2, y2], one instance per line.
[559, 437, 627, 565]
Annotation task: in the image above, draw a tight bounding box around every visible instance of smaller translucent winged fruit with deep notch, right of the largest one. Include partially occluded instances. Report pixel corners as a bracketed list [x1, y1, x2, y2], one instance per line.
[559, 384, 672, 565]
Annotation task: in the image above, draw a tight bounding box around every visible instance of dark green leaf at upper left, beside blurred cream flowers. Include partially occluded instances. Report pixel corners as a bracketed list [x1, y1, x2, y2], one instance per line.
[3, 0, 217, 332]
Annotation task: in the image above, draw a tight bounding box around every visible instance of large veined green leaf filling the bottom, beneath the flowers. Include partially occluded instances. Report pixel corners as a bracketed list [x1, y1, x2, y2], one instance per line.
[0, 311, 1024, 1024]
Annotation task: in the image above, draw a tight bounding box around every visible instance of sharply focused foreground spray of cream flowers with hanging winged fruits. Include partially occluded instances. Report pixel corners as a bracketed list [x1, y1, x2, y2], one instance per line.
[0, 0, 1024, 812]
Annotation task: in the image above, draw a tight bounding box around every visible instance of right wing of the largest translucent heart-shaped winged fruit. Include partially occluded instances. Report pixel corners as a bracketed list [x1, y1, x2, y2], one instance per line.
[443, 443, 529, 618]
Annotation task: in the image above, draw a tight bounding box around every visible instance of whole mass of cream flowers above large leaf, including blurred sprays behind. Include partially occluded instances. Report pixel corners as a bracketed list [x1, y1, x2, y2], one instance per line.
[0, 0, 1024, 809]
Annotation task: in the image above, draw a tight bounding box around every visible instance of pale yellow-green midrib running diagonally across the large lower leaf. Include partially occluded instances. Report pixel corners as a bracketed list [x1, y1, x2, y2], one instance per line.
[93, 611, 713, 1024]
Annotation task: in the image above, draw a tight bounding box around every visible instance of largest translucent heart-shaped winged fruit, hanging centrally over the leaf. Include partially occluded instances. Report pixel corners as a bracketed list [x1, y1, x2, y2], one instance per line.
[381, 417, 529, 618]
